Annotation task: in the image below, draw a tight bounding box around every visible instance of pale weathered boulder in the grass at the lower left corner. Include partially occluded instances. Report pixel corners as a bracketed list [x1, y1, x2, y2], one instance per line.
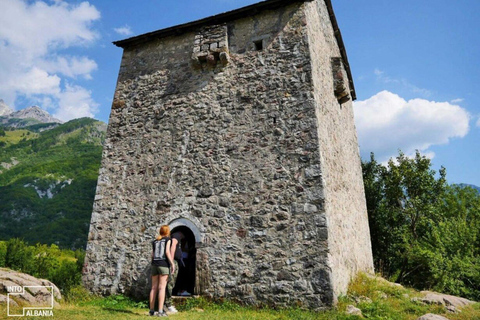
[0, 268, 62, 306]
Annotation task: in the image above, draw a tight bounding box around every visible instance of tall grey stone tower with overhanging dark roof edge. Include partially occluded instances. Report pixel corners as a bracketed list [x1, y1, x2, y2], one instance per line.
[83, 0, 373, 308]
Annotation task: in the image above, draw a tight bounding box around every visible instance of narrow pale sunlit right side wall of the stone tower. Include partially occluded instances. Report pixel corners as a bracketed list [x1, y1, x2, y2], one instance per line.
[306, 1, 373, 296]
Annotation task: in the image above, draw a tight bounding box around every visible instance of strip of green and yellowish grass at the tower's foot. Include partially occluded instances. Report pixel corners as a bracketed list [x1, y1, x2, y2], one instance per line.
[0, 276, 480, 320]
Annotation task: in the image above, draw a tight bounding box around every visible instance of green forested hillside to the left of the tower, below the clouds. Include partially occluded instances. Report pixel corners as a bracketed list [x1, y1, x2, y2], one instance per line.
[0, 118, 106, 249]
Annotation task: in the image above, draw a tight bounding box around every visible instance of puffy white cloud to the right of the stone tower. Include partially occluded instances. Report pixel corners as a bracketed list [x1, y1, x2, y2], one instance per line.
[354, 91, 470, 162]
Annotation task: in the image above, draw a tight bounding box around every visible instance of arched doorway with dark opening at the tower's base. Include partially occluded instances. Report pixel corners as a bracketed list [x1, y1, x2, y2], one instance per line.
[170, 218, 202, 296]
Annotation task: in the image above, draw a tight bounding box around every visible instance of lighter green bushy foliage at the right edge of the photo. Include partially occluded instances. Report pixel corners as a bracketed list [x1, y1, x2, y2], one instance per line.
[410, 185, 480, 300]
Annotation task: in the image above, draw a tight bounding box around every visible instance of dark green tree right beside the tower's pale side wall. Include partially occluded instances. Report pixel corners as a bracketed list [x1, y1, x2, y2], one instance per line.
[362, 152, 447, 281]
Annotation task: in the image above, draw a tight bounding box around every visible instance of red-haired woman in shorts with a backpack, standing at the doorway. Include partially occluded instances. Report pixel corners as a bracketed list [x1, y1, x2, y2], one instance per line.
[150, 225, 175, 317]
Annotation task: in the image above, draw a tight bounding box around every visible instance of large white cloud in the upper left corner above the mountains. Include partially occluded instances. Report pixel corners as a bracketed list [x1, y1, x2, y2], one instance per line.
[0, 0, 100, 119]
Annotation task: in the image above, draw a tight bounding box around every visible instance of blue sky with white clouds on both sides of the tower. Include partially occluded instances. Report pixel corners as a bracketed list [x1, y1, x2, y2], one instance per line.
[0, 0, 480, 185]
